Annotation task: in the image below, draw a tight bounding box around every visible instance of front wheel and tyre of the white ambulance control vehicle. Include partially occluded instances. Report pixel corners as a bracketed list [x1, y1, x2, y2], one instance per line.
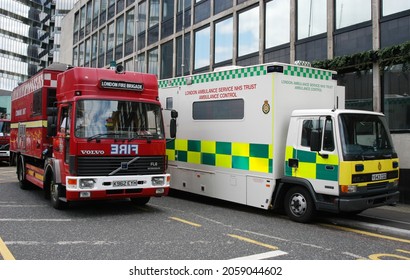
[284, 187, 316, 223]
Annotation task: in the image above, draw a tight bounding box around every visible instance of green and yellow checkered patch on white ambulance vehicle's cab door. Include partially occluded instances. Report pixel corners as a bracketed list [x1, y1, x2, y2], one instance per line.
[285, 146, 339, 181]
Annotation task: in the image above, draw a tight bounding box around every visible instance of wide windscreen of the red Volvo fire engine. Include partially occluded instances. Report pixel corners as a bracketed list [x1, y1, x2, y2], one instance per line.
[74, 100, 164, 140]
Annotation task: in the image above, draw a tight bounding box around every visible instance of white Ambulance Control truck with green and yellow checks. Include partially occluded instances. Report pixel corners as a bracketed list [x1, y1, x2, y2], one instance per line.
[159, 63, 399, 222]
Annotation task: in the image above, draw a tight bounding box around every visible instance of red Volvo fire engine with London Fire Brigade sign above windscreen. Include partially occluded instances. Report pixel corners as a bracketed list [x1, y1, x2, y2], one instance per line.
[10, 64, 176, 209]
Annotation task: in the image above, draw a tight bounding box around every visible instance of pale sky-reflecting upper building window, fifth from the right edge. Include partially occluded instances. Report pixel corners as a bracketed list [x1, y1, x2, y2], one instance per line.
[238, 6, 259, 56]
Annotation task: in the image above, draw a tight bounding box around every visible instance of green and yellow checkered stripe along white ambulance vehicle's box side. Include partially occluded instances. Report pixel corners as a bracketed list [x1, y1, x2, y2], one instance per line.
[167, 139, 272, 173]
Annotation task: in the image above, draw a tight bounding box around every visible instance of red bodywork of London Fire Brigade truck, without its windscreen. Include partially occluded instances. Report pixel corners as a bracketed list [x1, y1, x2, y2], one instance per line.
[10, 67, 170, 206]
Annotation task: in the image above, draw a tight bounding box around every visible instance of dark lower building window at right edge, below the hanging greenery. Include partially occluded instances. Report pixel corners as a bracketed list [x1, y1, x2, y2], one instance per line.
[382, 64, 410, 130]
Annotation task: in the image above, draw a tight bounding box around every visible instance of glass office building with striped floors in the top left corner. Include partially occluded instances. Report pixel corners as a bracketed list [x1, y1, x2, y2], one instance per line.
[0, 0, 77, 95]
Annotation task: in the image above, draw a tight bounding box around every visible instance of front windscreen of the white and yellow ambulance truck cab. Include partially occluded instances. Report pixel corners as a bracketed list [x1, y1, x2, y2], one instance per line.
[340, 114, 397, 160]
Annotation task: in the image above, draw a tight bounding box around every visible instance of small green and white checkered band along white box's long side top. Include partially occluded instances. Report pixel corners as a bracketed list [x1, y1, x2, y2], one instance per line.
[158, 65, 267, 88]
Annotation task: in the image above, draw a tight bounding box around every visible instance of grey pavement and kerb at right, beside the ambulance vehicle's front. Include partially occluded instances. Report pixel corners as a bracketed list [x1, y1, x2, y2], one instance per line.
[331, 204, 410, 241]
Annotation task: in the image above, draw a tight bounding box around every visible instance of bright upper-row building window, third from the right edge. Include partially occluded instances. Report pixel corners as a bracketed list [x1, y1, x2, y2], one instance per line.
[296, 0, 327, 40]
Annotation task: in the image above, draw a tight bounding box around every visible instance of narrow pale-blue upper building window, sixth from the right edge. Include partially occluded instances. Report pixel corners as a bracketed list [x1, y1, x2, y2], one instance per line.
[215, 17, 233, 63]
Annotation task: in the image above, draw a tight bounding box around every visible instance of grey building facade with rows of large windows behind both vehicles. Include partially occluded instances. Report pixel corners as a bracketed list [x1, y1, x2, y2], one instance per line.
[60, 0, 410, 203]
